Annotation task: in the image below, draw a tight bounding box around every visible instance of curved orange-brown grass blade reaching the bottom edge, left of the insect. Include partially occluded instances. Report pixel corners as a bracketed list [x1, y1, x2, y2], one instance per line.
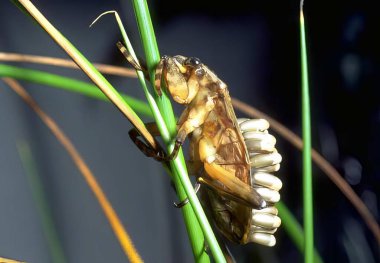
[0, 78, 143, 263]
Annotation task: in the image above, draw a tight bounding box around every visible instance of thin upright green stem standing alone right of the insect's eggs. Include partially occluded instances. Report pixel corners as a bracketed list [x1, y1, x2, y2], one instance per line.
[300, 5, 314, 263]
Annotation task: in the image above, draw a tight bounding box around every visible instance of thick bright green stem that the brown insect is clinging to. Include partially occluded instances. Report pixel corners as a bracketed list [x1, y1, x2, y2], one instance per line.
[132, 0, 221, 262]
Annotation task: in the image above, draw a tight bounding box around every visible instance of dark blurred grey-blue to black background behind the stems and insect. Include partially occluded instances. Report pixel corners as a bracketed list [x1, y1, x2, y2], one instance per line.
[0, 0, 380, 262]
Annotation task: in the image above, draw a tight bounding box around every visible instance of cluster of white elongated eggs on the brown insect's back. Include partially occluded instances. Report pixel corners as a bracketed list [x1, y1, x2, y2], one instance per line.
[238, 119, 282, 246]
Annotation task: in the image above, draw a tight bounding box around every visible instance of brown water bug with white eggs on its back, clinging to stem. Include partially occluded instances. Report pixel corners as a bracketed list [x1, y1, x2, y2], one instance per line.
[118, 43, 281, 246]
